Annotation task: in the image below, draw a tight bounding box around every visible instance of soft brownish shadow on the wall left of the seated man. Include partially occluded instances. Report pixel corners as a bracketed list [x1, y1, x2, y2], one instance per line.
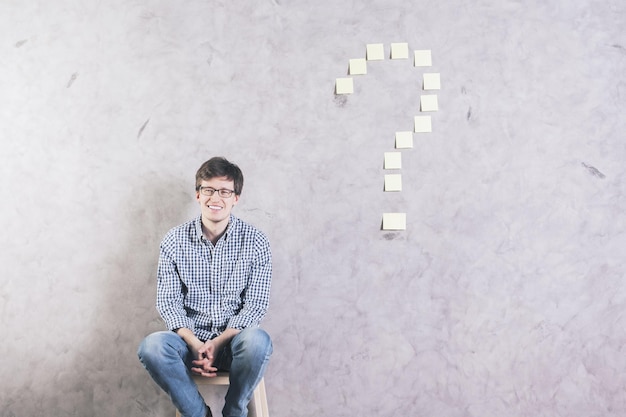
[12, 177, 194, 417]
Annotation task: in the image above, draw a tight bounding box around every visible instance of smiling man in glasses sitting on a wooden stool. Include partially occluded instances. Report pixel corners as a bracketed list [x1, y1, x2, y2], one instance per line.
[137, 157, 272, 417]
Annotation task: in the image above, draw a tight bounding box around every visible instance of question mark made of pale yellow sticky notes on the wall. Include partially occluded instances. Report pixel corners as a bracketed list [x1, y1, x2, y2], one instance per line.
[335, 42, 441, 230]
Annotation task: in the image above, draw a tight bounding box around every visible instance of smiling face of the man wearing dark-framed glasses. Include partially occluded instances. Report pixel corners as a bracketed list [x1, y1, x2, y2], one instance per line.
[196, 177, 239, 227]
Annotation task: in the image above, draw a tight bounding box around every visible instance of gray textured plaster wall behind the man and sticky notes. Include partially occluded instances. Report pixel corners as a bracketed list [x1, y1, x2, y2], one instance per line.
[0, 0, 626, 417]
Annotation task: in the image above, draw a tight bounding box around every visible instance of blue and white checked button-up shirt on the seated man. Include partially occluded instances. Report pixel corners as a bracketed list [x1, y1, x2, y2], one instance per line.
[157, 215, 272, 341]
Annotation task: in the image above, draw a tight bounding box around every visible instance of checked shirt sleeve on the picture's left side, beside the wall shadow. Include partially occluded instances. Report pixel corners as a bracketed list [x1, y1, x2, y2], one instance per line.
[156, 233, 195, 331]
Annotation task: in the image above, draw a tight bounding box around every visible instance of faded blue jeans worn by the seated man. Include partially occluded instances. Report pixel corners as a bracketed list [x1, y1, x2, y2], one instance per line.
[137, 327, 272, 417]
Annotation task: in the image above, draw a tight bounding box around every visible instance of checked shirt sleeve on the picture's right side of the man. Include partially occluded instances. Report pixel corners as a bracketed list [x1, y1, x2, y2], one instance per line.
[227, 232, 272, 329]
